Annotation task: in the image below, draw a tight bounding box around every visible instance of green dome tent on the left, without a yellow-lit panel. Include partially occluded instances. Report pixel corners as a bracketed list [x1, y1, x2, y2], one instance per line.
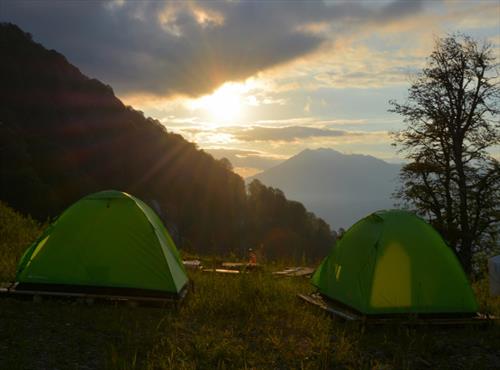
[16, 190, 188, 297]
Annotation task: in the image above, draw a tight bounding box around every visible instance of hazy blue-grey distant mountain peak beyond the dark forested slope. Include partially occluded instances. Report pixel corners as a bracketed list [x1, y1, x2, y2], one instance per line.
[249, 149, 400, 228]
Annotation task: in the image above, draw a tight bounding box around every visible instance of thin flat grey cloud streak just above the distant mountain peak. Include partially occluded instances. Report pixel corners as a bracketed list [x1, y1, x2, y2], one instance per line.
[232, 126, 355, 142]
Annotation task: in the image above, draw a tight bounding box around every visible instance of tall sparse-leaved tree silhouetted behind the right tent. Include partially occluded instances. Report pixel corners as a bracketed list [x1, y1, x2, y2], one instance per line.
[390, 35, 500, 273]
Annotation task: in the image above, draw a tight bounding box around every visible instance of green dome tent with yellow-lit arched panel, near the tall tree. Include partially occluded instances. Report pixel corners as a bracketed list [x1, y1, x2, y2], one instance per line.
[312, 210, 478, 315]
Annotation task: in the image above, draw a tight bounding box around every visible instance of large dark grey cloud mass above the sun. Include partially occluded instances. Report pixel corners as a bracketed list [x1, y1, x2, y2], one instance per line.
[0, 0, 421, 96]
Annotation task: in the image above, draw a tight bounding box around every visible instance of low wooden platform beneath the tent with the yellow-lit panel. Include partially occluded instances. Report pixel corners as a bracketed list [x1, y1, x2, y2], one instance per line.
[298, 293, 500, 326]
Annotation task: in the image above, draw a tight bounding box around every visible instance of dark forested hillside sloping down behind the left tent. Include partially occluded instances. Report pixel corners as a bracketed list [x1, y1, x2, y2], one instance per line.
[0, 24, 333, 258]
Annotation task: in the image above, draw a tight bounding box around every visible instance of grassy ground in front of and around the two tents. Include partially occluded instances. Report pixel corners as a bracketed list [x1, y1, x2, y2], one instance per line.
[0, 205, 500, 369]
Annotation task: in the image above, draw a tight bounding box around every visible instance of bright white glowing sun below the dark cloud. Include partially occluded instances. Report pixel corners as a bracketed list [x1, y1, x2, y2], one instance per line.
[191, 82, 246, 124]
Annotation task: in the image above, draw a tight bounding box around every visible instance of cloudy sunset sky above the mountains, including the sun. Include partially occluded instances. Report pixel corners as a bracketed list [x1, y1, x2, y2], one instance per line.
[0, 0, 500, 176]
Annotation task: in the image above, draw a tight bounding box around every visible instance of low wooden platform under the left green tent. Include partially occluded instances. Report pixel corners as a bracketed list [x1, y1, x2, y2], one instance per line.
[0, 283, 189, 306]
